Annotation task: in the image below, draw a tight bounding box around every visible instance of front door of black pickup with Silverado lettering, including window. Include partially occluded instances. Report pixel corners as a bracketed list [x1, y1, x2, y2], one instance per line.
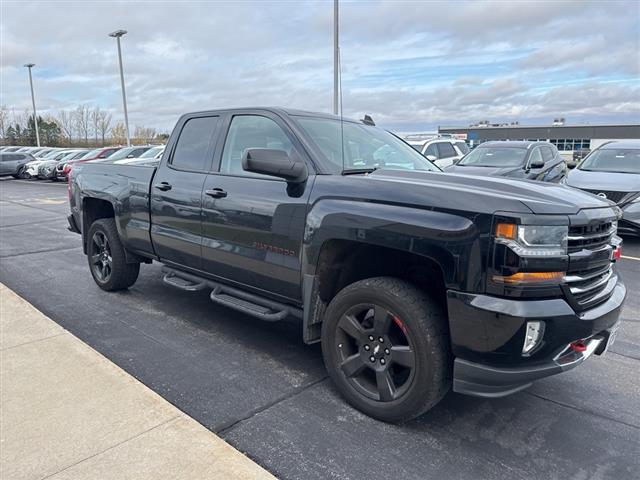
[202, 111, 313, 300]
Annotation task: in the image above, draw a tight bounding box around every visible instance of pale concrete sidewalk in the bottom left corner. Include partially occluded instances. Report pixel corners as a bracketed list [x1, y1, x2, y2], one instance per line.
[0, 284, 274, 480]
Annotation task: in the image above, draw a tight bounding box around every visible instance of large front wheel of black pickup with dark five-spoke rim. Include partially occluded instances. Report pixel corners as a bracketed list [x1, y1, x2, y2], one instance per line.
[322, 277, 453, 423]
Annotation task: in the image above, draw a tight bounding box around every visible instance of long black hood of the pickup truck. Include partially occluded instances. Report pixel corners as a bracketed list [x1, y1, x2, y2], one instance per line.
[367, 169, 615, 215]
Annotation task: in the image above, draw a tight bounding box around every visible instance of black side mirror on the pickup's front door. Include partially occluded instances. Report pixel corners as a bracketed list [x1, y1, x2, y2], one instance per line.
[242, 148, 309, 183]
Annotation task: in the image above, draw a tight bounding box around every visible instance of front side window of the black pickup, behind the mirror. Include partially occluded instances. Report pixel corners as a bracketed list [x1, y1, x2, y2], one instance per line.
[220, 115, 293, 178]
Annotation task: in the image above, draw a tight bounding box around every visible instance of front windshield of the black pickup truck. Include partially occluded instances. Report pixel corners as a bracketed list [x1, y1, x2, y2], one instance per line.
[298, 117, 439, 173]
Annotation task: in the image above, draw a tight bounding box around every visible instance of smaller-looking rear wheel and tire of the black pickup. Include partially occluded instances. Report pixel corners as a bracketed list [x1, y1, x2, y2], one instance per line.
[87, 218, 140, 292]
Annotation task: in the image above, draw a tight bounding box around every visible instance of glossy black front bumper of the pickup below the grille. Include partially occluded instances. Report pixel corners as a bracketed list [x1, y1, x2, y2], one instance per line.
[447, 281, 626, 397]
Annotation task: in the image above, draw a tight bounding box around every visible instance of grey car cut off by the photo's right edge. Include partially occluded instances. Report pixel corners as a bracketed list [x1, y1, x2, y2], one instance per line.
[565, 140, 640, 236]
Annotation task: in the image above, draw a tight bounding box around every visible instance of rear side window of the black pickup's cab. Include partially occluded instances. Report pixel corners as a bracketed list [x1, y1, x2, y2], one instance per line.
[171, 117, 218, 171]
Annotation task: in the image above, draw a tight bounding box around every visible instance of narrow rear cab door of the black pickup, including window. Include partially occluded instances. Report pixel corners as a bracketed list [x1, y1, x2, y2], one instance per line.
[150, 115, 220, 270]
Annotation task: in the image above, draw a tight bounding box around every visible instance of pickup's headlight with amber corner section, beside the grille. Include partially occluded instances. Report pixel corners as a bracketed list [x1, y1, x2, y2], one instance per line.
[495, 223, 569, 257]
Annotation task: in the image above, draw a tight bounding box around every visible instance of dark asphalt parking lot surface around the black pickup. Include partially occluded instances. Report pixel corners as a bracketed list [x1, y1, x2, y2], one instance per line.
[0, 180, 640, 480]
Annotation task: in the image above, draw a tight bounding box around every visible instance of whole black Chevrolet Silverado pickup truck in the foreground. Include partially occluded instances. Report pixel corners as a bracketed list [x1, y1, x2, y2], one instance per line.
[69, 108, 626, 422]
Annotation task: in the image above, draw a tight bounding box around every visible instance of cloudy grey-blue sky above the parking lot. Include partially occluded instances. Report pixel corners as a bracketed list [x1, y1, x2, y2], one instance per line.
[0, 0, 640, 131]
